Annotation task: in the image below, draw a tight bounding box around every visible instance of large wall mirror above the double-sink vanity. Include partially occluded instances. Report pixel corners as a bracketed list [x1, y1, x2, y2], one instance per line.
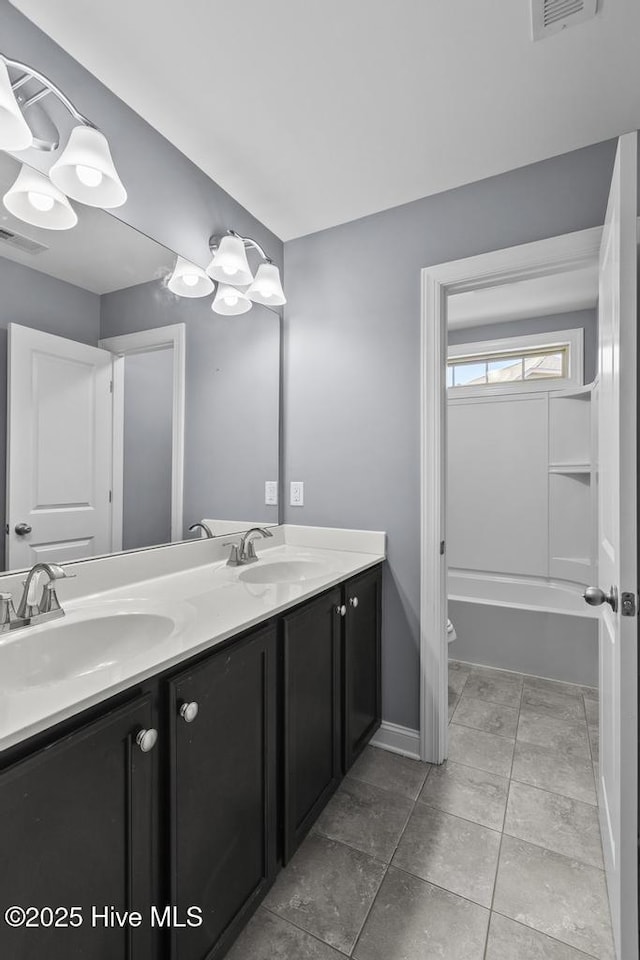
[0, 153, 280, 570]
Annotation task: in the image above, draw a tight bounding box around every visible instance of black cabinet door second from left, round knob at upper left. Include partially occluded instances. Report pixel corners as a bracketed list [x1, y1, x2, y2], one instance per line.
[169, 628, 276, 960]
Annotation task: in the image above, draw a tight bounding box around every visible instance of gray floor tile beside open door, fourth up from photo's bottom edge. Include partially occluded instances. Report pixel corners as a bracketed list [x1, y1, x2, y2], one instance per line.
[511, 740, 597, 804]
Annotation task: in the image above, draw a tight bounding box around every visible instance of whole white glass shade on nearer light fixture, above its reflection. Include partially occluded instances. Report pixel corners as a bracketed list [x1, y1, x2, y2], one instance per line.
[49, 124, 127, 210]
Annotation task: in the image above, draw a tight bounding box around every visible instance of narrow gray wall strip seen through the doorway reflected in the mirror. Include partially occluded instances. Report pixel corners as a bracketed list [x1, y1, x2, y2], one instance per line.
[122, 350, 173, 550]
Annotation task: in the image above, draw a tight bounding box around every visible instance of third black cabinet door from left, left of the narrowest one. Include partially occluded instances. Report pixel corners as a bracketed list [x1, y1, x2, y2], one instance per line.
[283, 590, 343, 863]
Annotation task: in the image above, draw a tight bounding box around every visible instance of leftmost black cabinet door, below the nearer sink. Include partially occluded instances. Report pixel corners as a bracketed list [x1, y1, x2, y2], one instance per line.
[0, 697, 157, 960]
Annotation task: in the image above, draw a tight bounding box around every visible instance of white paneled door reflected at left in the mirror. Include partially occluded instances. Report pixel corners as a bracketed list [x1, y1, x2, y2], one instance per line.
[6, 323, 112, 569]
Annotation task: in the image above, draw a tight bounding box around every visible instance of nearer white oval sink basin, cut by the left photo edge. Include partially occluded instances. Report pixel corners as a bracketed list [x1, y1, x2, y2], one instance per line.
[0, 611, 176, 690]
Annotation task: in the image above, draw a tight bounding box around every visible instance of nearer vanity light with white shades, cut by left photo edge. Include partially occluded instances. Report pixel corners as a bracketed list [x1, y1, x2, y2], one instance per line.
[0, 53, 127, 223]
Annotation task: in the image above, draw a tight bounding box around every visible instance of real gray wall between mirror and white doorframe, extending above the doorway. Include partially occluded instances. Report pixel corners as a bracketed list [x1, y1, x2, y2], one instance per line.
[284, 142, 632, 728]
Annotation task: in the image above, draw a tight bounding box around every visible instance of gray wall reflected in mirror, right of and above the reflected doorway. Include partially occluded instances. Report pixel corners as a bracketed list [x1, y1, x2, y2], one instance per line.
[100, 283, 280, 536]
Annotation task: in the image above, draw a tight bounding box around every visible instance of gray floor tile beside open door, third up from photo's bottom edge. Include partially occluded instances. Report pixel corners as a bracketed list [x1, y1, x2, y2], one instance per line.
[504, 782, 604, 869]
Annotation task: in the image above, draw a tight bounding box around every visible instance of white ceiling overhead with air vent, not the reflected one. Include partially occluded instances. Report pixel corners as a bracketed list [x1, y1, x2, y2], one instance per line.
[7, 0, 640, 240]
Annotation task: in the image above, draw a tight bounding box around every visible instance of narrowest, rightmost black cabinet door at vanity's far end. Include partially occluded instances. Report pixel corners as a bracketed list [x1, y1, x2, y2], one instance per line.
[344, 567, 382, 772]
